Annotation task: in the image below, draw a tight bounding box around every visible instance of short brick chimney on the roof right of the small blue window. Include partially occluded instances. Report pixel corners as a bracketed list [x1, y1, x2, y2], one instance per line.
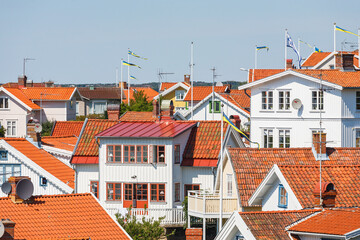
[313, 182, 337, 208]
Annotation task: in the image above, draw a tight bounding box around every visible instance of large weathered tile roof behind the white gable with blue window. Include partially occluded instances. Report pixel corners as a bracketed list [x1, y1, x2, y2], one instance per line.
[228, 148, 360, 207]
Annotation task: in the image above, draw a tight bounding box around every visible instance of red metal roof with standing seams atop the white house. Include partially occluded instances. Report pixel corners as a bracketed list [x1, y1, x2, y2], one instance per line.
[96, 122, 196, 138]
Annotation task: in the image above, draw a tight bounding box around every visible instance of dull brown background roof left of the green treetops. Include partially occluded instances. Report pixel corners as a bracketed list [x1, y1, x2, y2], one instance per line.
[78, 87, 125, 100]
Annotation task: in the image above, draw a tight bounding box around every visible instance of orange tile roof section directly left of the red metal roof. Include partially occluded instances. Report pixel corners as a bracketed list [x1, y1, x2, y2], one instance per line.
[71, 119, 119, 164]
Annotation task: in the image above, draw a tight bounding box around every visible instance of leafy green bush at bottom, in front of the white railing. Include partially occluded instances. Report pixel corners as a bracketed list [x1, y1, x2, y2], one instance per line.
[115, 207, 175, 240]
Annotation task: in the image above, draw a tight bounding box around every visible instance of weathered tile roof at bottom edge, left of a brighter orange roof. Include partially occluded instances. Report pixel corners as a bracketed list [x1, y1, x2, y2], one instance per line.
[239, 210, 320, 240]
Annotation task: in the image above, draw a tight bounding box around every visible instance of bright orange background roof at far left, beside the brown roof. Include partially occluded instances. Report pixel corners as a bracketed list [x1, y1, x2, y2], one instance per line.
[21, 87, 76, 101]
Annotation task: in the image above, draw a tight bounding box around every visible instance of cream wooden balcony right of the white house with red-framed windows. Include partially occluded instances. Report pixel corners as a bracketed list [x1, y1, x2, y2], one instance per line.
[188, 190, 239, 218]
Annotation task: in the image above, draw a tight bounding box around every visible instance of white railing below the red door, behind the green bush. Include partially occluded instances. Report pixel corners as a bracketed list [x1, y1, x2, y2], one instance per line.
[106, 208, 185, 225]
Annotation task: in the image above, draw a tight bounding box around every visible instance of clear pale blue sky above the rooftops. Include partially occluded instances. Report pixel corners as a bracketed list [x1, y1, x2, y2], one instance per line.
[0, 0, 360, 85]
